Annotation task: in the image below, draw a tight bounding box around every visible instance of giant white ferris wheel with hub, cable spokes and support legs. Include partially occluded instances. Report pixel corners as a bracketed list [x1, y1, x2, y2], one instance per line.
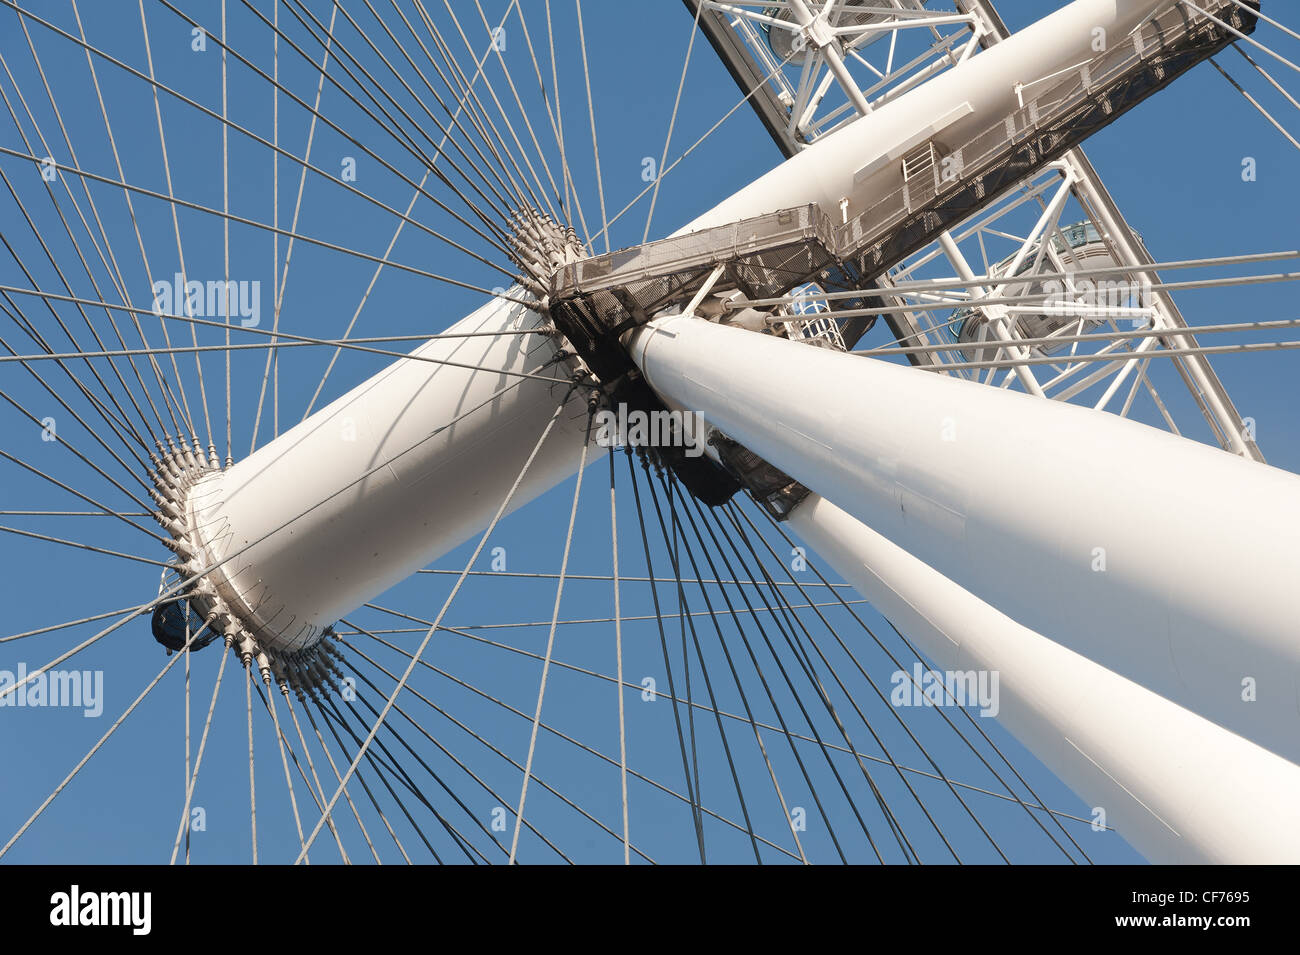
[0, 0, 1300, 864]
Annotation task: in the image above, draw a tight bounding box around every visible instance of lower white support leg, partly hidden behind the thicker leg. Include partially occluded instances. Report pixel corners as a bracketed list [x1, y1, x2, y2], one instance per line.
[789, 495, 1300, 864]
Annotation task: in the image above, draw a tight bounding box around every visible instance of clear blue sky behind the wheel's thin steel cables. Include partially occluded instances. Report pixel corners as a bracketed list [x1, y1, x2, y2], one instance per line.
[0, 0, 1300, 863]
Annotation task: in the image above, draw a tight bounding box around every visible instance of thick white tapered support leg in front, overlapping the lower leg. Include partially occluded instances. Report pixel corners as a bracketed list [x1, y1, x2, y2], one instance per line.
[632, 316, 1300, 760]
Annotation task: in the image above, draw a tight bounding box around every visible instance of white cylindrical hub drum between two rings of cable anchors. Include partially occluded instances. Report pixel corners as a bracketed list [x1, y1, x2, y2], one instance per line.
[190, 294, 588, 651]
